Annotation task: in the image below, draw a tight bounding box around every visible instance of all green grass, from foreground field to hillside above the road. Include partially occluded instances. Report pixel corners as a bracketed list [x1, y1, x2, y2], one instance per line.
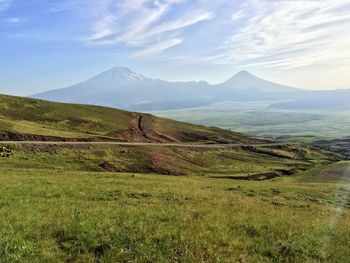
[0, 96, 350, 263]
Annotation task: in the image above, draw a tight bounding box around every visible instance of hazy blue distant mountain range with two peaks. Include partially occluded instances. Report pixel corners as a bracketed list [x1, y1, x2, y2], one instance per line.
[31, 67, 350, 111]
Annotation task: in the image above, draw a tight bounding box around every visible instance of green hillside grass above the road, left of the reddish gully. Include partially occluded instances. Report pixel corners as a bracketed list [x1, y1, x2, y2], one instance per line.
[0, 95, 130, 137]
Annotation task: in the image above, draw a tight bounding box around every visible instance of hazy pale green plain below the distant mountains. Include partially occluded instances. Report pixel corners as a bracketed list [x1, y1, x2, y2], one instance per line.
[150, 102, 350, 142]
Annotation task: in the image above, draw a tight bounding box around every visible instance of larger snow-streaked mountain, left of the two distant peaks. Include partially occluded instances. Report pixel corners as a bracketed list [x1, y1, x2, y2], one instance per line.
[32, 67, 210, 110]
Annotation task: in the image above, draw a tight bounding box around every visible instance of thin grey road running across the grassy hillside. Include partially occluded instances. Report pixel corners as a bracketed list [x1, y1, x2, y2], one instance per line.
[0, 141, 293, 148]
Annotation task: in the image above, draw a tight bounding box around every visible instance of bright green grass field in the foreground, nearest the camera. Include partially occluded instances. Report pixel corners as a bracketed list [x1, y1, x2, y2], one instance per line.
[0, 162, 350, 263]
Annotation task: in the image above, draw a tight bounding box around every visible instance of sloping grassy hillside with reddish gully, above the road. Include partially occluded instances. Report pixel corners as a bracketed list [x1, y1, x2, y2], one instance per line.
[0, 95, 258, 143]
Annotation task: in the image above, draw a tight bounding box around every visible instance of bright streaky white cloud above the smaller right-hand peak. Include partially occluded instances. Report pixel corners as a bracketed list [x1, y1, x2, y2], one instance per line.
[221, 0, 350, 68]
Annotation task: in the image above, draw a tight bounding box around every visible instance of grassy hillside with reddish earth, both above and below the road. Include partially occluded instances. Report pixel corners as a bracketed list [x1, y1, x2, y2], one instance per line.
[0, 93, 337, 178]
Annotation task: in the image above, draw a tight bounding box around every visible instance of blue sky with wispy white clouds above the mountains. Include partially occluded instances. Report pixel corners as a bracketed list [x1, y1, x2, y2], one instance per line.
[0, 0, 350, 95]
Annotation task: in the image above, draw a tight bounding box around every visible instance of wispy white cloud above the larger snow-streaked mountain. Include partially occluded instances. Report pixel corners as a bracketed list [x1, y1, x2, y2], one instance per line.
[88, 0, 215, 57]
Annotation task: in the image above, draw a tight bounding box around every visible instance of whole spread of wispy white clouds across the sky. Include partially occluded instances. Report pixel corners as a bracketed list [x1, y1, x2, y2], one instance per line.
[10, 0, 350, 69]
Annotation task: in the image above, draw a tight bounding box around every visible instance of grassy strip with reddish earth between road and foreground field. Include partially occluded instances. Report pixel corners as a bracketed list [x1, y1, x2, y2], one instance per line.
[0, 145, 334, 176]
